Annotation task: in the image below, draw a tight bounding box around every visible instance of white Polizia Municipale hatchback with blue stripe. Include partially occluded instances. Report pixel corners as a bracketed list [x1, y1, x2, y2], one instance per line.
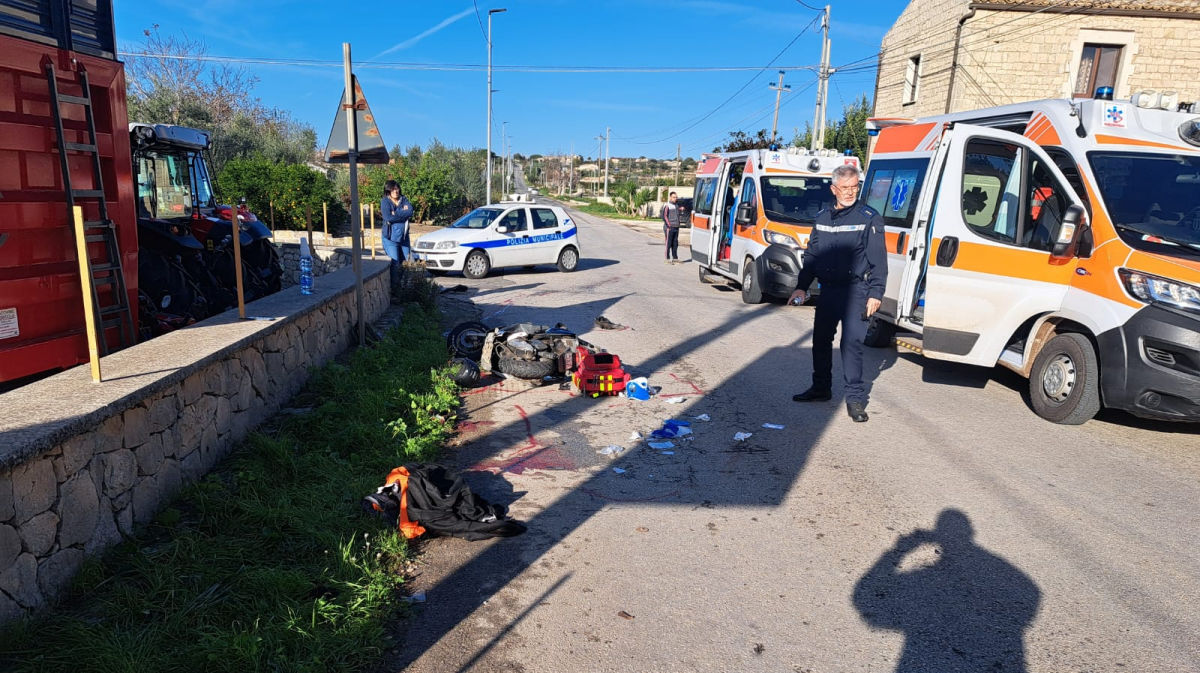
[413, 203, 580, 278]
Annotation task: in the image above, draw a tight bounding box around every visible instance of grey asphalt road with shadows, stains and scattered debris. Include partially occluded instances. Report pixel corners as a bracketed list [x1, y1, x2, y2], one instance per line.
[386, 200, 1200, 673]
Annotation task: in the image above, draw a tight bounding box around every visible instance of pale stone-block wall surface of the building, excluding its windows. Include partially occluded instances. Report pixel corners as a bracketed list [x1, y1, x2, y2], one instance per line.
[874, 0, 1200, 118]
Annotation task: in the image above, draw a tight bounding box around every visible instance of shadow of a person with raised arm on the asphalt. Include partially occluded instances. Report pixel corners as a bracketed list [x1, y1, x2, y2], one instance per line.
[853, 509, 1040, 673]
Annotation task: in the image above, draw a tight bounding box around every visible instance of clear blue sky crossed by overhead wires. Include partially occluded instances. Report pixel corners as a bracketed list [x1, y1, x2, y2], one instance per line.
[115, 0, 907, 157]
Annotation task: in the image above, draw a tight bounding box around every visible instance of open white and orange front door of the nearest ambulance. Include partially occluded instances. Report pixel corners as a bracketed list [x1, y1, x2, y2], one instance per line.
[910, 124, 1080, 366]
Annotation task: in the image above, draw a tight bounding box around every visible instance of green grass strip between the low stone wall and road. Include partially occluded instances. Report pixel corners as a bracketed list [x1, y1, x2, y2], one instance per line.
[0, 304, 458, 673]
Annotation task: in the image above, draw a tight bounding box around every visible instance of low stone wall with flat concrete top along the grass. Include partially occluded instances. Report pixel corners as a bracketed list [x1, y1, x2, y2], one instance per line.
[0, 260, 390, 621]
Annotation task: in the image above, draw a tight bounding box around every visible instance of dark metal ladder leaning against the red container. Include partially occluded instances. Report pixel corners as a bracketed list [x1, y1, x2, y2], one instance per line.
[46, 61, 137, 355]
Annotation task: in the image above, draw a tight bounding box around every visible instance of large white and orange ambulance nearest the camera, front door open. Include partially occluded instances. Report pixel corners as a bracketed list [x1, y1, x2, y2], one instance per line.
[863, 92, 1200, 423]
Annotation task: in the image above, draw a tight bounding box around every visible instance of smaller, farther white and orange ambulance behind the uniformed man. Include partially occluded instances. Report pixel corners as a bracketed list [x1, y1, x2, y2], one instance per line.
[691, 148, 859, 304]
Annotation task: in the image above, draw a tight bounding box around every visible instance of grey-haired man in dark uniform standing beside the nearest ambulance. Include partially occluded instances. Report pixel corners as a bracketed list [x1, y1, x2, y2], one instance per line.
[790, 164, 888, 422]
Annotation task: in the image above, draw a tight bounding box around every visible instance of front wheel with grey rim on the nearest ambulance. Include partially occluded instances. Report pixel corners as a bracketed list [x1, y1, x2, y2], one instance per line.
[1030, 332, 1100, 426]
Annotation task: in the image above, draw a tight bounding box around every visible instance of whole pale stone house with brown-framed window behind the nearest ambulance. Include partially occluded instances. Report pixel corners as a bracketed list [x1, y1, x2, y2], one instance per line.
[875, 0, 1200, 118]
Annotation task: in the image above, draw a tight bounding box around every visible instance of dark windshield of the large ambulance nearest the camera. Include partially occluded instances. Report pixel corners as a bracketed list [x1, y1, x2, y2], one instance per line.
[1087, 152, 1200, 252]
